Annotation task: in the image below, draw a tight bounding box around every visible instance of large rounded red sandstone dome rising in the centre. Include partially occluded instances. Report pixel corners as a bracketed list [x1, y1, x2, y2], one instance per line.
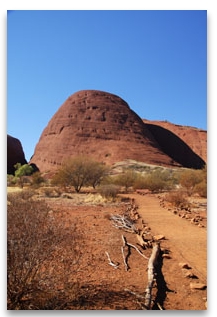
[30, 90, 180, 171]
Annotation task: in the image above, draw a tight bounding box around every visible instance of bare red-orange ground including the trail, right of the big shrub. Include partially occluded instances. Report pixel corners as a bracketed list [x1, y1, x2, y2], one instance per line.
[47, 193, 207, 310]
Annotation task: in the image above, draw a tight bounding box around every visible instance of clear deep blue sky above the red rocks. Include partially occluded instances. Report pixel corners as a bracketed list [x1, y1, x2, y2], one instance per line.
[7, 10, 207, 160]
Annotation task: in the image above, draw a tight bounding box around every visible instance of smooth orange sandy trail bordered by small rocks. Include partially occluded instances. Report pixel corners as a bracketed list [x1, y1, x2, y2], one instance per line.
[128, 194, 207, 282]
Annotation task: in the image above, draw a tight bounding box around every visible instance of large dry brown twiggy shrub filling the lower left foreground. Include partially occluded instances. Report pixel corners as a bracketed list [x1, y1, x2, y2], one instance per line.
[7, 193, 84, 310]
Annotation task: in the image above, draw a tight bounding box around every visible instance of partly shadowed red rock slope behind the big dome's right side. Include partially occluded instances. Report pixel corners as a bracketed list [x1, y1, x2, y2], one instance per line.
[143, 119, 207, 168]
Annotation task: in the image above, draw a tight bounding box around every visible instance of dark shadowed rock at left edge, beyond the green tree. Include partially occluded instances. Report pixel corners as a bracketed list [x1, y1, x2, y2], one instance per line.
[7, 135, 27, 174]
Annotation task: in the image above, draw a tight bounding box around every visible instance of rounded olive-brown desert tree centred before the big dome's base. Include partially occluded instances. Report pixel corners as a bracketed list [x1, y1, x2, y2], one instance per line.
[52, 156, 107, 193]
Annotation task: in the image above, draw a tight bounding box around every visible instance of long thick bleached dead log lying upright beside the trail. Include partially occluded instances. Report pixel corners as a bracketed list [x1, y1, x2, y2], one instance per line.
[145, 243, 160, 309]
